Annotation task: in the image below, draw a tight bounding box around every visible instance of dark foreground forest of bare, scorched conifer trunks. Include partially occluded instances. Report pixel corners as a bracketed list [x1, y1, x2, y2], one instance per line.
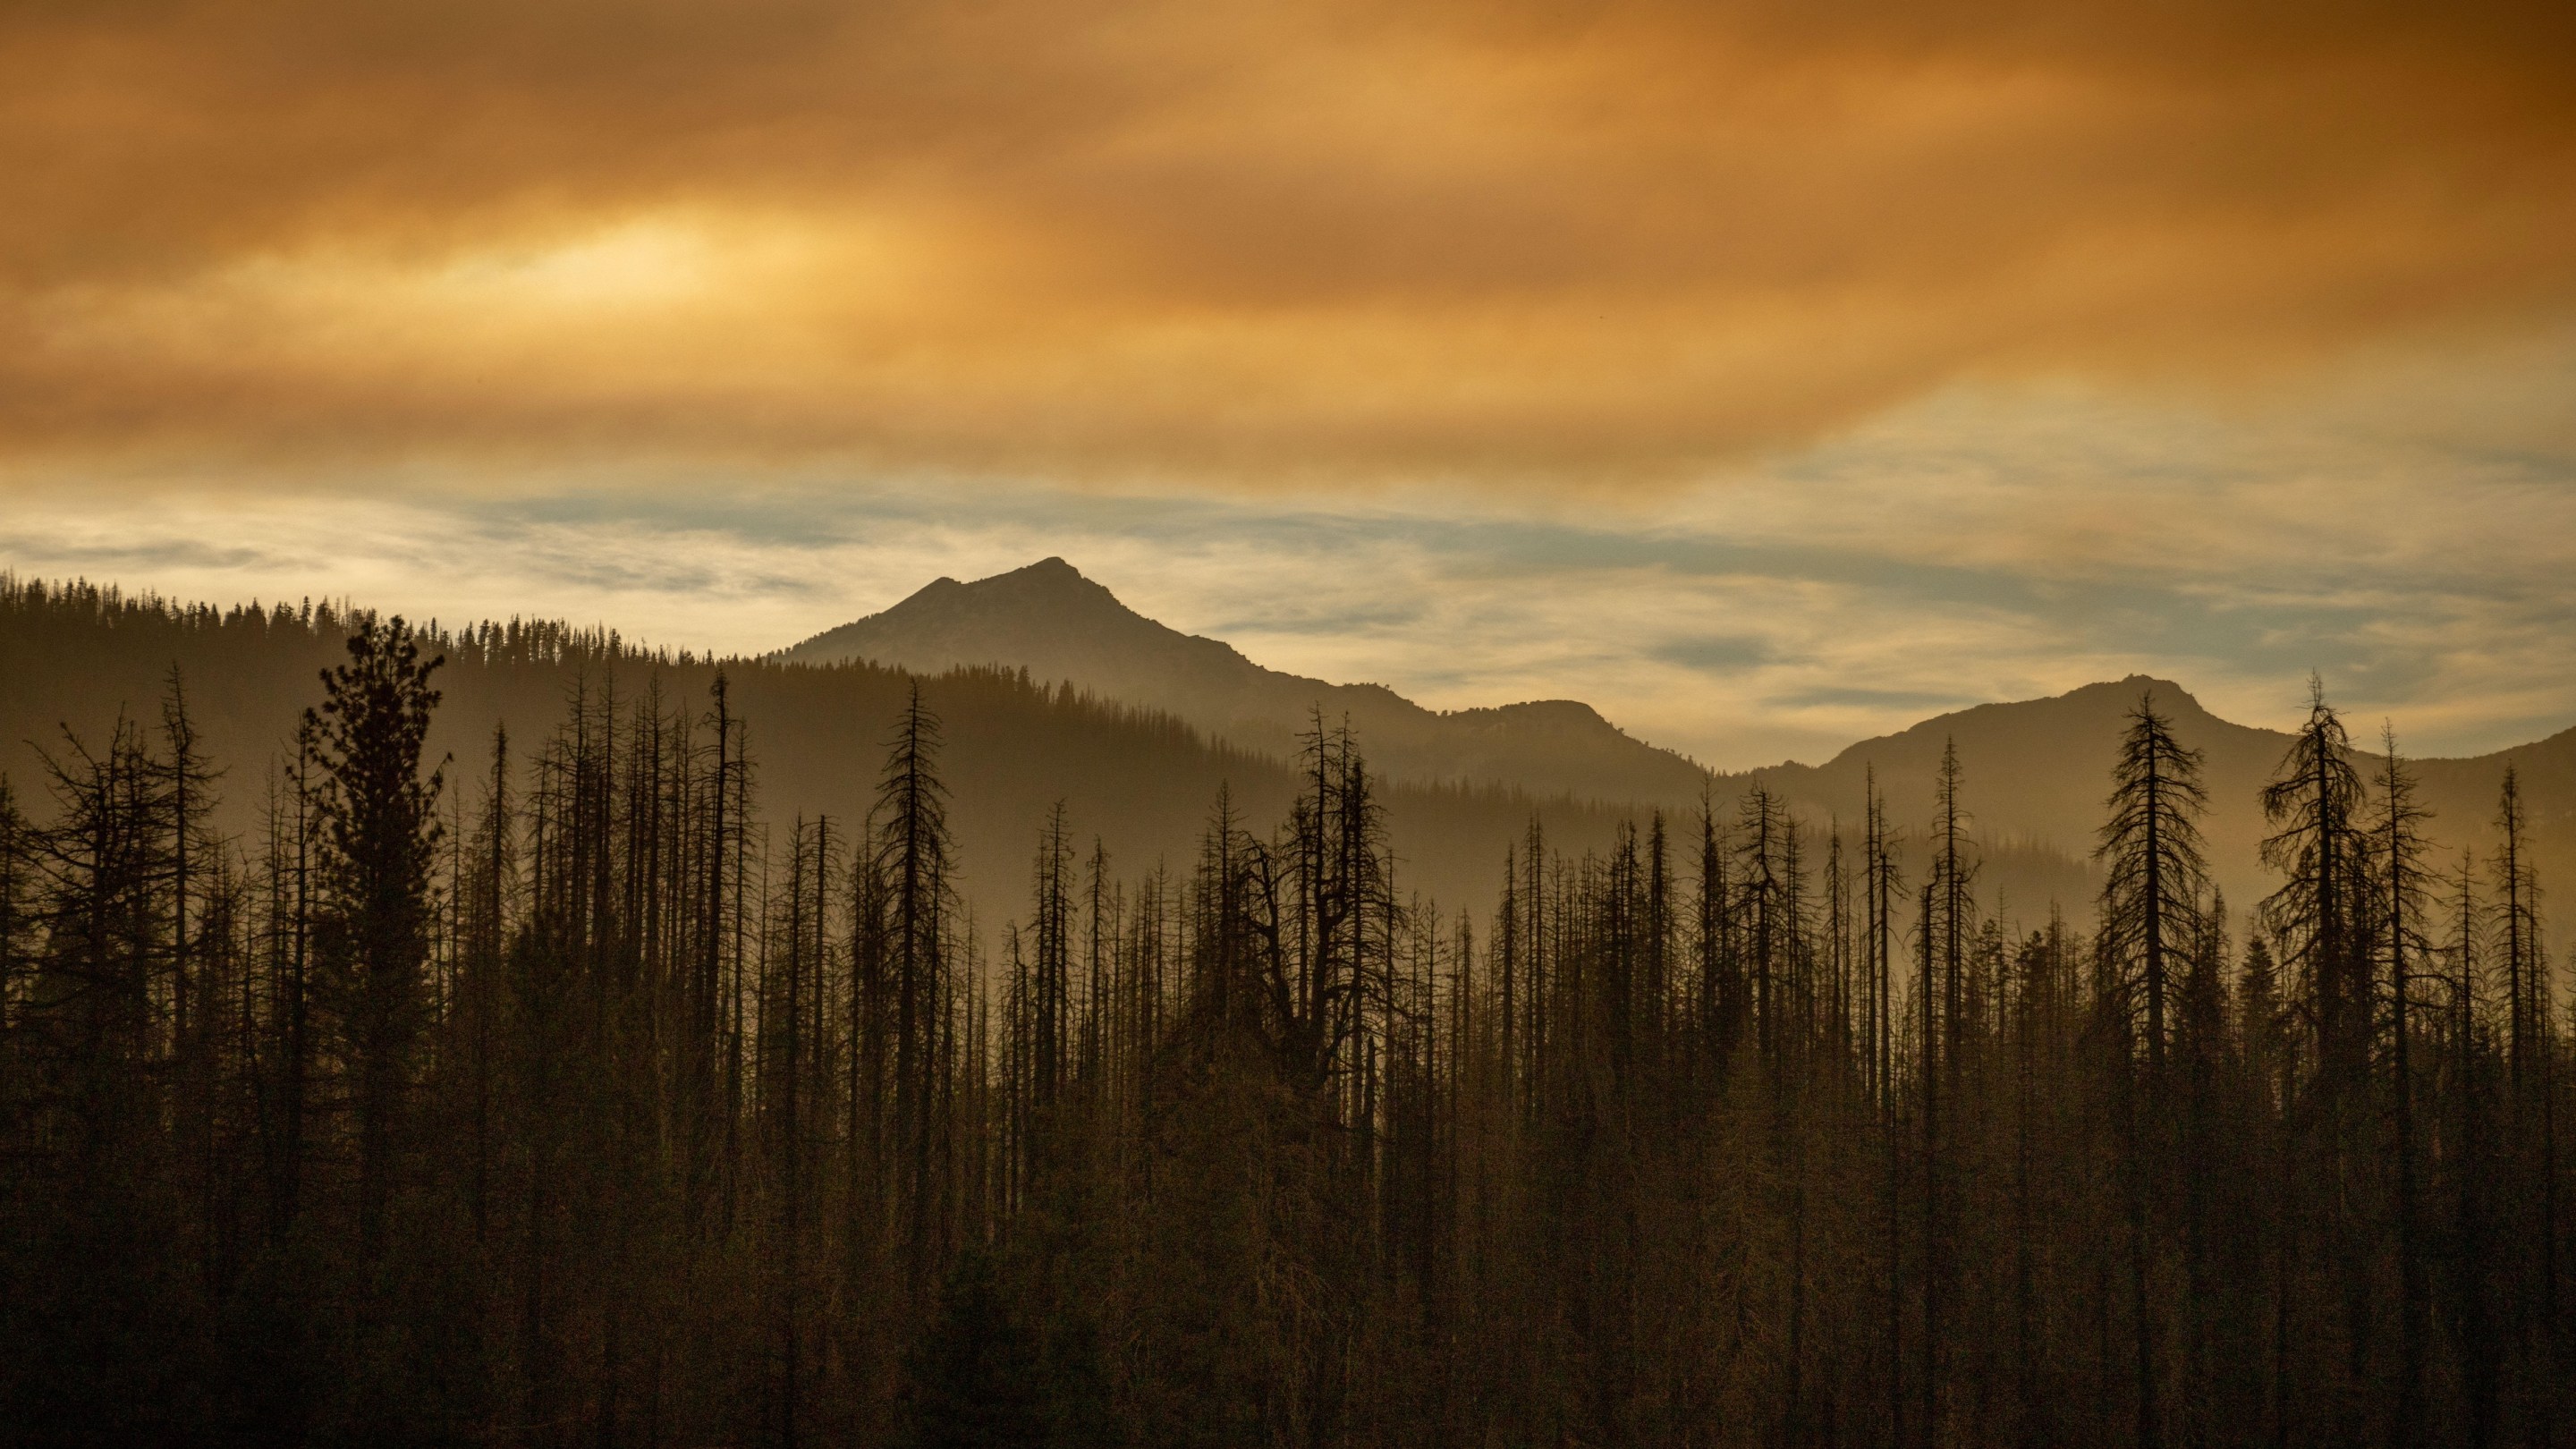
[0, 619, 2576, 1446]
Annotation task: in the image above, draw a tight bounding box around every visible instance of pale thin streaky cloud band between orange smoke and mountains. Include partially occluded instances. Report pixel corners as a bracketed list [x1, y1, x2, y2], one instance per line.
[0, 363, 2576, 768]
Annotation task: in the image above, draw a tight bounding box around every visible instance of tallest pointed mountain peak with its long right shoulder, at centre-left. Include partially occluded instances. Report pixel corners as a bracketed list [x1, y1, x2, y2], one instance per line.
[773, 560, 1703, 801]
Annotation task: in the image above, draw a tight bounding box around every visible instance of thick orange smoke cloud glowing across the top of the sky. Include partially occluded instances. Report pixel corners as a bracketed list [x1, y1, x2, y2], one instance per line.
[0, 0, 2576, 479]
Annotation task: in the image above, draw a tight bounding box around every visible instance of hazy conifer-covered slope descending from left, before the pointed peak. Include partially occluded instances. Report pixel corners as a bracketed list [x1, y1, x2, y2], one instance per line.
[0, 575, 1615, 912]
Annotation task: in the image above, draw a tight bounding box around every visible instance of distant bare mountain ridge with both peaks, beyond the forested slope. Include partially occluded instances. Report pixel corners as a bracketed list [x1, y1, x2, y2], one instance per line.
[773, 560, 2576, 938]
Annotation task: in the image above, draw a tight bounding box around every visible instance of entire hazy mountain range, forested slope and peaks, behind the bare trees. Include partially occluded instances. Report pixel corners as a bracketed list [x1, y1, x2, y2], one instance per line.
[0, 562, 2576, 941]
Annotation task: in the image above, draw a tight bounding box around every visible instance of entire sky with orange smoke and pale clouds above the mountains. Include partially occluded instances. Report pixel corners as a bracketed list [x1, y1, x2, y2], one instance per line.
[0, 0, 2576, 766]
